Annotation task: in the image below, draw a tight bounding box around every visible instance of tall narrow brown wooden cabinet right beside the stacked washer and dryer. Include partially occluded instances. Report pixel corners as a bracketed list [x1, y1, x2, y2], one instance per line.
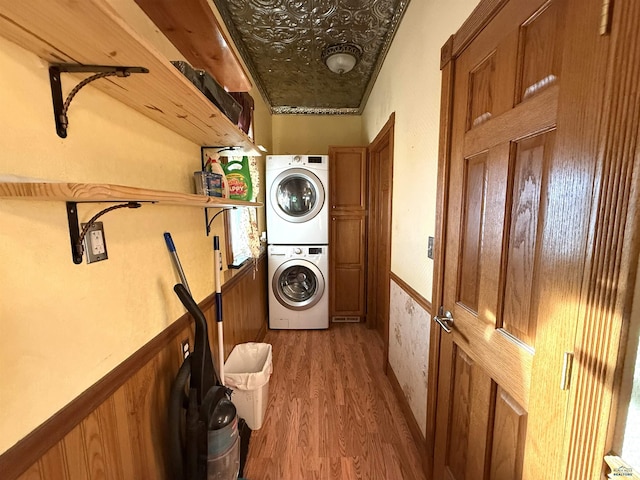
[329, 147, 368, 322]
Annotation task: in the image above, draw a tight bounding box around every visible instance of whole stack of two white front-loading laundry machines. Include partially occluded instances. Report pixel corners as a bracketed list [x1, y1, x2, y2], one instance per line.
[266, 155, 329, 329]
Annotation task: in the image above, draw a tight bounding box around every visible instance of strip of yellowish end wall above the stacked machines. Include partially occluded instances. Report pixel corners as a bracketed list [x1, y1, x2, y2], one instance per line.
[269, 115, 365, 155]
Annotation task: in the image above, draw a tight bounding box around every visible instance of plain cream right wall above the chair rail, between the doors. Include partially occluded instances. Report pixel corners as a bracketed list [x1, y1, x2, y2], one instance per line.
[362, 0, 478, 300]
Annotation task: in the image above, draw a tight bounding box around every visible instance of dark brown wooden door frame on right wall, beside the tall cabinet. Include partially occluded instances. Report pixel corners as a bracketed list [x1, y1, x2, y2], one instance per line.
[366, 112, 395, 372]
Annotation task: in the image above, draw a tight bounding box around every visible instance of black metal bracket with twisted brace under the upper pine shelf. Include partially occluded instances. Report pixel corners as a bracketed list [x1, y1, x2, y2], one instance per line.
[49, 63, 149, 138]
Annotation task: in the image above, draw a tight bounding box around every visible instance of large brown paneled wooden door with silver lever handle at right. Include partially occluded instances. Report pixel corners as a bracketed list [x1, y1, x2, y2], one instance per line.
[431, 0, 606, 480]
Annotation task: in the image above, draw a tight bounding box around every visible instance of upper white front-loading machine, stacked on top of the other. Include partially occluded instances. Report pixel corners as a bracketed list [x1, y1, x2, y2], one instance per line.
[266, 155, 329, 245]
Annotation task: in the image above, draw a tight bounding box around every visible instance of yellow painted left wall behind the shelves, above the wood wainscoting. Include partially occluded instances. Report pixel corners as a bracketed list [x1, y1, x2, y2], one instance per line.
[0, 9, 271, 453]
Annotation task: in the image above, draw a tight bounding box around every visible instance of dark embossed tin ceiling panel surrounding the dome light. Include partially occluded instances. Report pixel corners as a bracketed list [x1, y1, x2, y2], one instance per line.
[214, 0, 409, 114]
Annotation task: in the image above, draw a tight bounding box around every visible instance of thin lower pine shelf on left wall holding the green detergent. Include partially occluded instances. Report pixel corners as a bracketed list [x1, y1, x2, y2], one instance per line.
[0, 182, 262, 208]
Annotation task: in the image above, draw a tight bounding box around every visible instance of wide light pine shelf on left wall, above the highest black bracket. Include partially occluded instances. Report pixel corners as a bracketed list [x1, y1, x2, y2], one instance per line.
[0, 0, 261, 155]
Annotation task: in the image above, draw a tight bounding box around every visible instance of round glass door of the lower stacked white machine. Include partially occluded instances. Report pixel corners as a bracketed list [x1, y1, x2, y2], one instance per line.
[272, 260, 324, 310]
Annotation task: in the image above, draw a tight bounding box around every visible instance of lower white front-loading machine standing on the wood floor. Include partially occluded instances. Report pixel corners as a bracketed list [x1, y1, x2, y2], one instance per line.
[267, 245, 329, 330]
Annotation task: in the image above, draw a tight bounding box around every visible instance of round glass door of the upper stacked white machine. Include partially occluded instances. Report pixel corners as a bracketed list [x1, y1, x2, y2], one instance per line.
[271, 168, 325, 223]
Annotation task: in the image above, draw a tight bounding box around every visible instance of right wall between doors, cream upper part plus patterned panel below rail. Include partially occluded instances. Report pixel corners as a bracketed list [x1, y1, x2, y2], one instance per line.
[363, 0, 478, 434]
